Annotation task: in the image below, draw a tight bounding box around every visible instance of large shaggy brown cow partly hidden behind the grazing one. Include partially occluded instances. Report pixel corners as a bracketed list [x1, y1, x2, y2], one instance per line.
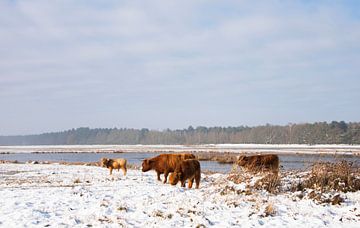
[142, 154, 195, 183]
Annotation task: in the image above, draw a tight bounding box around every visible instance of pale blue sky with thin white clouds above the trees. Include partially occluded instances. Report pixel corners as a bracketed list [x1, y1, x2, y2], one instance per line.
[0, 0, 360, 135]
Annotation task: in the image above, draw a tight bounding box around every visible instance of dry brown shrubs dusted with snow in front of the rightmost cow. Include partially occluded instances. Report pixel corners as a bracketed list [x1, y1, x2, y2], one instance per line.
[225, 161, 360, 206]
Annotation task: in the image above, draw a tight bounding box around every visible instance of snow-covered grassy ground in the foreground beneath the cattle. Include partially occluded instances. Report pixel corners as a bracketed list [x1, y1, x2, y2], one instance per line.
[0, 164, 360, 227]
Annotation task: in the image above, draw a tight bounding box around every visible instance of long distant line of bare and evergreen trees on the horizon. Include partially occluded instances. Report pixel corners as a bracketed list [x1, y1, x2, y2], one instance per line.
[0, 121, 360, 145]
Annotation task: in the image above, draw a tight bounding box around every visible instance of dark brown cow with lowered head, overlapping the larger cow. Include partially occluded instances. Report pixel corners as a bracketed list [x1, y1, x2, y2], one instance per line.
[169, 159, 201, 188]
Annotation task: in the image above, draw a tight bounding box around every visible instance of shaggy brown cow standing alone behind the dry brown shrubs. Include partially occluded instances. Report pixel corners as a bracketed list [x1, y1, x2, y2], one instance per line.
[236, 154, 279, 172]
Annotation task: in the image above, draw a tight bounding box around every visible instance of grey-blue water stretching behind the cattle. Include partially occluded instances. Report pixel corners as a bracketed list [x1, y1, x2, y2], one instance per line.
[0, 152, 360, 173]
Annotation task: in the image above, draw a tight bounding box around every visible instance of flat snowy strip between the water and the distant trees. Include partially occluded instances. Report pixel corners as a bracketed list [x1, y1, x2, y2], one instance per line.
[0, 144, 360, 155]
